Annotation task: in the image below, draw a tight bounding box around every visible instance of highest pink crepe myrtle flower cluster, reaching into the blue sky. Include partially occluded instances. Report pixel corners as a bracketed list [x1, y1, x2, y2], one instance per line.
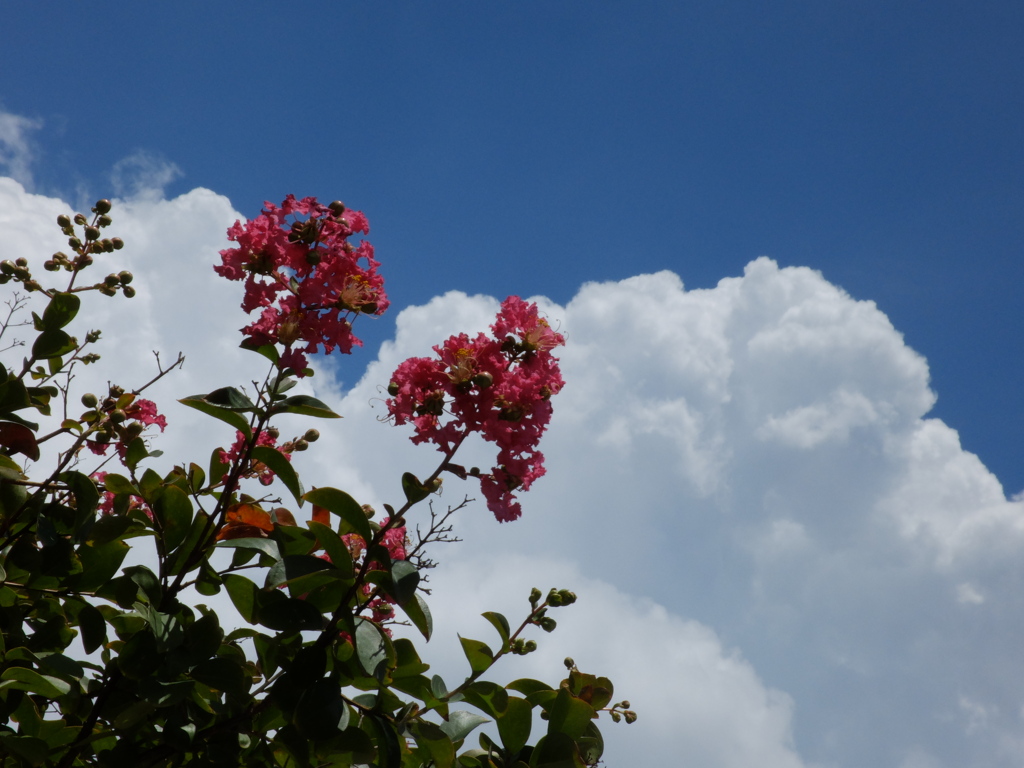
[214, 195, 388, 376]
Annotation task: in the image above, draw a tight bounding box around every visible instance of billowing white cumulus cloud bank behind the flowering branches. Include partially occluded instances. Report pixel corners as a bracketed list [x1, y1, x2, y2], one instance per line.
[0, 174, 1024, 768]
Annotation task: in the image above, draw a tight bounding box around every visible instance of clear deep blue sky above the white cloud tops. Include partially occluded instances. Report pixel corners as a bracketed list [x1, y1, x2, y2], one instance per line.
[0, 2, 1024, 489]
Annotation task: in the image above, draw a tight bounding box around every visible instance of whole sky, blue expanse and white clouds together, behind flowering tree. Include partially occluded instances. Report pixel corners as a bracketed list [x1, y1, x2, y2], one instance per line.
[6, 2, 1024, 768]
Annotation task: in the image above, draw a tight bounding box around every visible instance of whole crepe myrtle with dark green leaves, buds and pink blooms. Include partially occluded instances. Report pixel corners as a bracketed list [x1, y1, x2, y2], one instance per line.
[0, 197, 635, 768]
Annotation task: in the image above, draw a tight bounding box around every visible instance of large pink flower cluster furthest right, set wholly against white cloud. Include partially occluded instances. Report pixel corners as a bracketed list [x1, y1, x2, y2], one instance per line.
[387, 296, 565, 522]
